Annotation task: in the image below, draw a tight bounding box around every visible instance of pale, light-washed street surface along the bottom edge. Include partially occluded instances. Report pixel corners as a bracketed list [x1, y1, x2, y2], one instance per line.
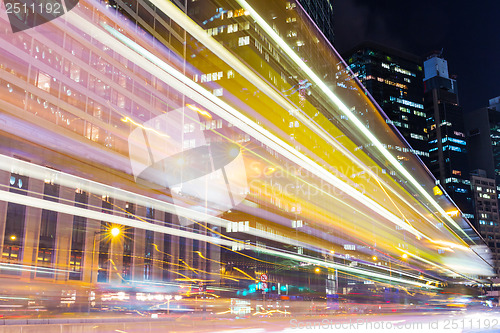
[0, 311, 500, 333]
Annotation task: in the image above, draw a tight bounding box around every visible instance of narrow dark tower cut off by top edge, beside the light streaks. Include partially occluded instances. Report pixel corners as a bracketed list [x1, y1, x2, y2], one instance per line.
[298, 0, 335, 44]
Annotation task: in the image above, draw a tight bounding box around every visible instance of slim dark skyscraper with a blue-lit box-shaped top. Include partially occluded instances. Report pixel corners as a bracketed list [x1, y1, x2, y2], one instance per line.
[424, 54, 474, 219]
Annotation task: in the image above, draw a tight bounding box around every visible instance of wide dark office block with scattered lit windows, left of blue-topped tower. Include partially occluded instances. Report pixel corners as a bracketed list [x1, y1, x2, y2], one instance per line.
[344, 42, 428, 162]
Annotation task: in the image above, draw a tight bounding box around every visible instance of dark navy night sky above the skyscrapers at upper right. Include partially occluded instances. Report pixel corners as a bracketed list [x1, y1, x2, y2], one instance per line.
[334, 0, 500, 112]
